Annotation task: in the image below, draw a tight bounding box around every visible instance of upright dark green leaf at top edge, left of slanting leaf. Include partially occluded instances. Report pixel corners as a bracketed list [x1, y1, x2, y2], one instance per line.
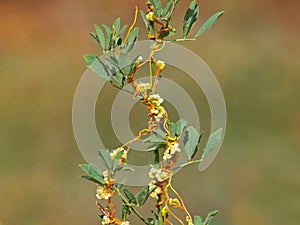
[183, 0, 199, 37]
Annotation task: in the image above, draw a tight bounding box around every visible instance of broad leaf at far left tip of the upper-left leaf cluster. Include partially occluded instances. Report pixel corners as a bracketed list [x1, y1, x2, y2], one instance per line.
[84, 55, 111, 81]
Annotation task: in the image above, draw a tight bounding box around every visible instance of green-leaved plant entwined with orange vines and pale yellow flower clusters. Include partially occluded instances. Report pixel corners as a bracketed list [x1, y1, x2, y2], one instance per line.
[80, 0, 223, 225]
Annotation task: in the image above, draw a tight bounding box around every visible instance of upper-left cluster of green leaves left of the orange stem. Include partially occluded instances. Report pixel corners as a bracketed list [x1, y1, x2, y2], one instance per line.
[84, 18, 140, 88]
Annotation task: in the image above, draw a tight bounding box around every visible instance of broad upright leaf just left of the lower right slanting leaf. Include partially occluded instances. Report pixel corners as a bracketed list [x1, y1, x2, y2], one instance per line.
[183, 126, 201, 160]
